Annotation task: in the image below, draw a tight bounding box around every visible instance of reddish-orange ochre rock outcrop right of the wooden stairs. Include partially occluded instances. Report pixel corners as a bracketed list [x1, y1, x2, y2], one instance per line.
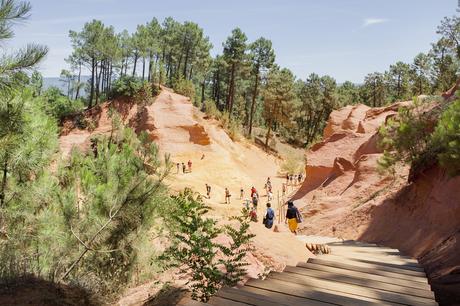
[294, 100, 460, 304]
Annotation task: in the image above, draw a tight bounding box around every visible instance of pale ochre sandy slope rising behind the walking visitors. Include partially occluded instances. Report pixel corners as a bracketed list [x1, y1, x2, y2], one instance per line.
[153, 91, 292, 216]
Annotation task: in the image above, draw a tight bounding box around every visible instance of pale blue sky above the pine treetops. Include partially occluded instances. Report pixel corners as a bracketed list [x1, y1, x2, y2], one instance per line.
[13, 0, 458, 83]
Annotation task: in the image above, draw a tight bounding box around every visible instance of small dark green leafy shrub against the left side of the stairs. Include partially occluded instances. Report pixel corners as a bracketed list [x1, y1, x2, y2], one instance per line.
[160, 189, 254, 302]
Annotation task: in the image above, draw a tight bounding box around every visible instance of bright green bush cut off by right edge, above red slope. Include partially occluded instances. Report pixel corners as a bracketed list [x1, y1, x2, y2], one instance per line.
[433, 100, 460, 175]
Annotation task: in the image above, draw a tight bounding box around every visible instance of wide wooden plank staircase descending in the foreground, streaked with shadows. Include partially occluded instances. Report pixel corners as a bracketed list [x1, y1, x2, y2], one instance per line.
[178, 241, 437, 306]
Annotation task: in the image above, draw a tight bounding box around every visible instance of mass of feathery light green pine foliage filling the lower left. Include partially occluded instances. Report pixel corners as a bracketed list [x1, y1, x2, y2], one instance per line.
[0, 101, 170, 296]
